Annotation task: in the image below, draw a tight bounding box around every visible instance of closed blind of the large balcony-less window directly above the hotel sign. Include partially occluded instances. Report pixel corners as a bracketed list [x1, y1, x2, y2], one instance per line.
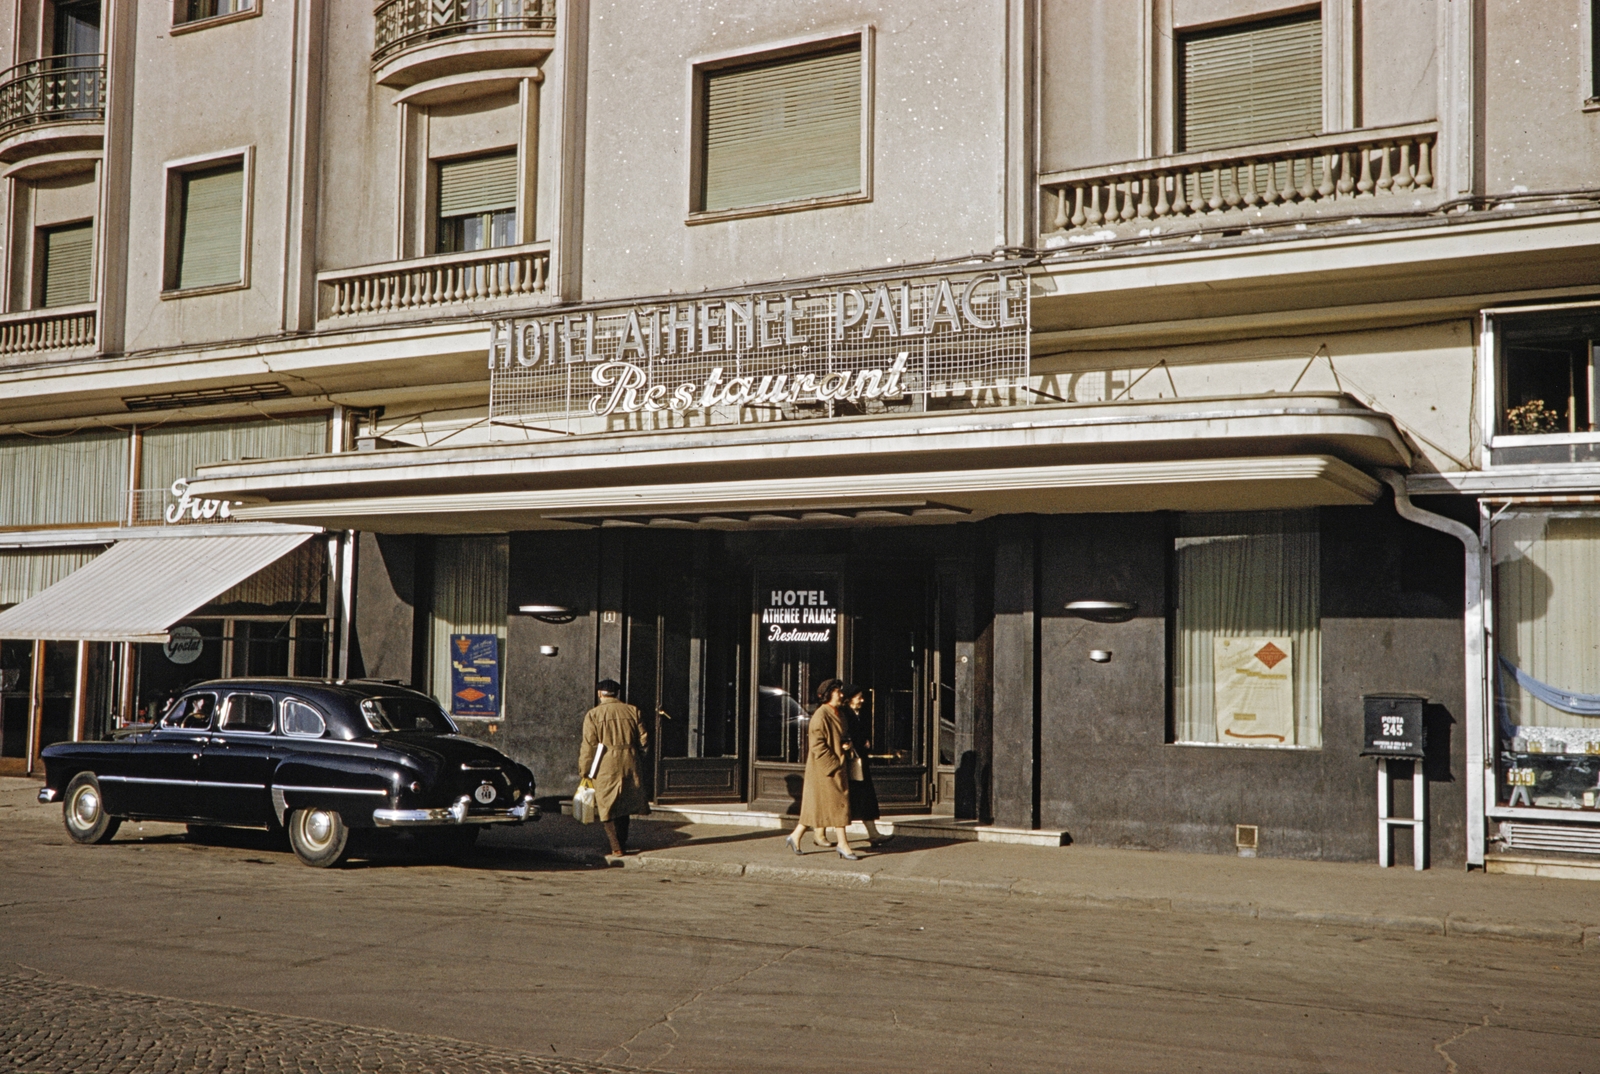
[699, 43, 861, 211]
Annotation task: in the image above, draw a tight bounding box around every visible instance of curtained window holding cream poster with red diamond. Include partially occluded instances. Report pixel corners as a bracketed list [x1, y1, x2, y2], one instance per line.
[1173, 511, 1322, 749]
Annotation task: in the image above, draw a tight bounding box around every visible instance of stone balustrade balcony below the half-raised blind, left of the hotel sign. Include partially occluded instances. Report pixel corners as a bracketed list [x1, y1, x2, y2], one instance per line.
[317, 242, 550, 328]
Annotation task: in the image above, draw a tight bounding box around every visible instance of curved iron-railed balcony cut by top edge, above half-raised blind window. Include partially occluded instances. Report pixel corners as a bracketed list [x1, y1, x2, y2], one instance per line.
[373, 0, 555, 88]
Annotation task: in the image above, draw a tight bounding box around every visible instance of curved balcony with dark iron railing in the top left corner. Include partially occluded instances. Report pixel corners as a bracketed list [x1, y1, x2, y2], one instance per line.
[0, 53, 106, 163]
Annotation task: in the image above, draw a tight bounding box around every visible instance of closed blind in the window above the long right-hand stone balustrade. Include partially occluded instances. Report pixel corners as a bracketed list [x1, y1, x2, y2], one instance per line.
[1179, 11, 1322, 152]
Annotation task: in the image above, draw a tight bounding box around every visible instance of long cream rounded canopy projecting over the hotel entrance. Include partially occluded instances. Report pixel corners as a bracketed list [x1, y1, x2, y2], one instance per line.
[194, 394, 1411, 533]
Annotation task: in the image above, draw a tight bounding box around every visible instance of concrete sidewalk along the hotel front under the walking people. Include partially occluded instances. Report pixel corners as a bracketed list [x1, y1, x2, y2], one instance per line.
[482, 815, 1600, 954]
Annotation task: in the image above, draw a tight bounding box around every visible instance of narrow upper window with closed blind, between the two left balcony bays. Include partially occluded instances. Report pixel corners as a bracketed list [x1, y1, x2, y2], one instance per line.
[163, 157, 246, 291]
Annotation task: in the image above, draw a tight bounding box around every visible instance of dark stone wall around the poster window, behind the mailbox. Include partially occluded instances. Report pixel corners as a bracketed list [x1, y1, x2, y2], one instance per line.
[1030, 507, 1466, 864]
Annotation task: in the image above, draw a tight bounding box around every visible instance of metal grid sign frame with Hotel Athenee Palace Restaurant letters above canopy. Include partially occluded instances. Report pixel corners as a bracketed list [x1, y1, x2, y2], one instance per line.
[488, 271, 1029, 432]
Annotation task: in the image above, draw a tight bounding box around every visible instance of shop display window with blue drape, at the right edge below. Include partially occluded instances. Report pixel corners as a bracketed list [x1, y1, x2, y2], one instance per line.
[1491, 509, 1600, 810]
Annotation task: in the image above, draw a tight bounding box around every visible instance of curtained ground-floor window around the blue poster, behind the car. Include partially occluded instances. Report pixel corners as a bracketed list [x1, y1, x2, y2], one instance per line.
[429, 536, 510, 712]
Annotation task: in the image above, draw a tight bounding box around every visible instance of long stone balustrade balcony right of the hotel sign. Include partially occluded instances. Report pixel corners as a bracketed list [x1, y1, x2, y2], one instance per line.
[1038, 123, 1440, 248]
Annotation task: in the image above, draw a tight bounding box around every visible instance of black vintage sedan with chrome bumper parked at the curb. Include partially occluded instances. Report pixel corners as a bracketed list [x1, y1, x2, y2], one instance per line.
[38, 679, 539, 868]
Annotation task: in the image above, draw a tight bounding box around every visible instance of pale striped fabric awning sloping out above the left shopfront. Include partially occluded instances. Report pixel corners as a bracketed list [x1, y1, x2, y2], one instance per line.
[0, 530, 314, 642]
